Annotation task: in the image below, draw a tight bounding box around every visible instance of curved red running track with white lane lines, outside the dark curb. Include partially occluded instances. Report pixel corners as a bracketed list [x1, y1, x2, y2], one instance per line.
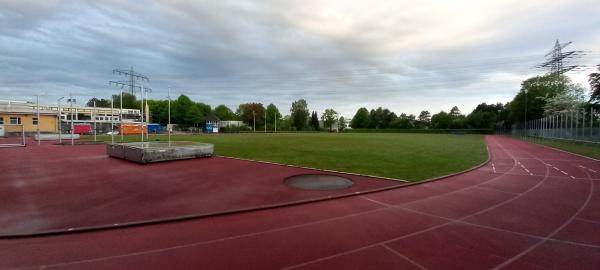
[0, 136, 600, 269]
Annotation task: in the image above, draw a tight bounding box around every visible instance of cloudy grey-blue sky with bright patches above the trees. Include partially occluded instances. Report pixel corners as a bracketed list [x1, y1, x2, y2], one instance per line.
[0, 0, 600, 117]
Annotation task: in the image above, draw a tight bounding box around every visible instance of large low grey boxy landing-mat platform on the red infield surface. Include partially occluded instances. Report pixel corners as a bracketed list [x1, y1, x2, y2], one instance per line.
[106, 142, 214, 163]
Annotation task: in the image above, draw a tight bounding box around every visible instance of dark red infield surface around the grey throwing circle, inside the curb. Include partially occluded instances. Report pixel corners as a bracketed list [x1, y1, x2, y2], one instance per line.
[0, 143, 404, 237]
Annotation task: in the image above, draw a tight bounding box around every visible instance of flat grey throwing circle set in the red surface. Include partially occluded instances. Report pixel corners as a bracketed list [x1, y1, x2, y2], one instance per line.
[285, 174, 354, 190]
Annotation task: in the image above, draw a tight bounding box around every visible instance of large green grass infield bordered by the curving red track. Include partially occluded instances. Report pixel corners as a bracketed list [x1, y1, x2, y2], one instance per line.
[87, 133, 487, 181]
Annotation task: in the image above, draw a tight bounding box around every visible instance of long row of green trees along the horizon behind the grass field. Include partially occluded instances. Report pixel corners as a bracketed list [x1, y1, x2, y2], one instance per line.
[87, 66, 600, 131]
